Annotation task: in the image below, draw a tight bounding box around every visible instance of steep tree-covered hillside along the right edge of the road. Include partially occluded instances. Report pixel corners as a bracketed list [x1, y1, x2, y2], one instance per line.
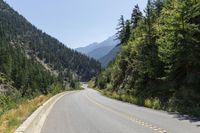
[95, 0, 200, 116]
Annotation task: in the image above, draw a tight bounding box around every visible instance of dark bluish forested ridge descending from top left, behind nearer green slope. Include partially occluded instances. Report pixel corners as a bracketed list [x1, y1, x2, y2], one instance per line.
[0, 0, 100, 81]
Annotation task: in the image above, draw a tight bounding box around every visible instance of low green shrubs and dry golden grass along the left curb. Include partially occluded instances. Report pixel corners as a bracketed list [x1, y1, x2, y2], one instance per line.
[0, 84, 81, 133]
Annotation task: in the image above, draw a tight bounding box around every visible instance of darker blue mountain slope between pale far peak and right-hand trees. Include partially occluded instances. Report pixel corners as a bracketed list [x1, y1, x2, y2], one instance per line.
[99, 45, 121, 67]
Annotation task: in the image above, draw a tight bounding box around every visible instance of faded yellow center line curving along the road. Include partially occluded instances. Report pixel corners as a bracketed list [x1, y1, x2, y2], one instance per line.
[86, 93, 169, 133]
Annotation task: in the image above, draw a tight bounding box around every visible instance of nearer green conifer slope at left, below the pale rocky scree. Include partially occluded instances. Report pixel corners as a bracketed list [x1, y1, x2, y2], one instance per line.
[0, 39, 55, 96]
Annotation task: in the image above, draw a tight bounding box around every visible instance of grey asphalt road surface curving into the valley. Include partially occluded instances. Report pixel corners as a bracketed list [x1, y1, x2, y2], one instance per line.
[42, 86, 200, 133]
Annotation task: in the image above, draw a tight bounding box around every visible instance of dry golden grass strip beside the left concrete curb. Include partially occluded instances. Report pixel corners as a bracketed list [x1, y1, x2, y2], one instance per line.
[0, 95, 50, 133]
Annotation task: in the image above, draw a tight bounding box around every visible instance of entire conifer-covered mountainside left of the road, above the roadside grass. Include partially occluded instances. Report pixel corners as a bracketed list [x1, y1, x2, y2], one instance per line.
[0, 0, 101, 95]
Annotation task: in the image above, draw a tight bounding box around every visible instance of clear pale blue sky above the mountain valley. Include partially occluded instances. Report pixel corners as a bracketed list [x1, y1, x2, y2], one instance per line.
[5, 0, 147, 48]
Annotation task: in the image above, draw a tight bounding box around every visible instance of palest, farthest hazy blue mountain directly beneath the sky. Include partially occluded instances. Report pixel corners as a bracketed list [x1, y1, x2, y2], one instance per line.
[76, 36, 119, 60]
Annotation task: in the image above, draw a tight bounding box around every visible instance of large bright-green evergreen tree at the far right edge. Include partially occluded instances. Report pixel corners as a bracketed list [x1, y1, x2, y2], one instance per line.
[158, 0, 200, 112]
